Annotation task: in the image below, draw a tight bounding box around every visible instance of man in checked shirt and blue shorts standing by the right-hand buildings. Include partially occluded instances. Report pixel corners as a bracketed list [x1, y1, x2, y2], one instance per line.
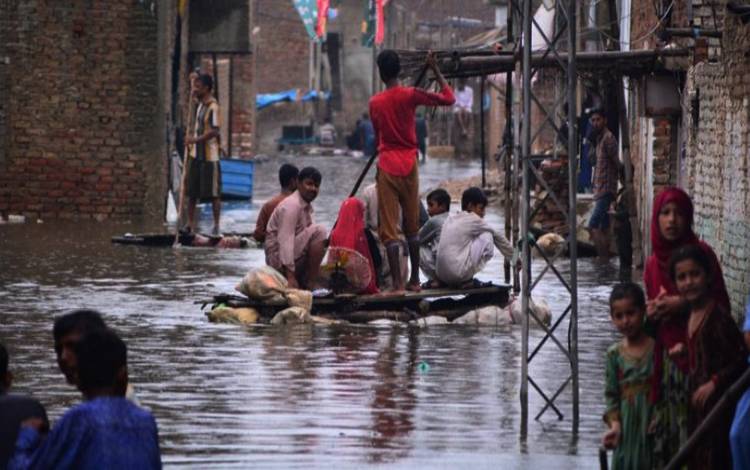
[589, 108, 620, 261]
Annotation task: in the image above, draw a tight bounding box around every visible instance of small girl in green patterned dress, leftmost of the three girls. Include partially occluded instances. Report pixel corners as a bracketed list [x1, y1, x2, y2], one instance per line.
[602, 282, 654, 470]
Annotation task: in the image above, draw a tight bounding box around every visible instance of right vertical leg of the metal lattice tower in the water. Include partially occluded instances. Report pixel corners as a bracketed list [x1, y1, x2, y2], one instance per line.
[567, 0, 579, 434]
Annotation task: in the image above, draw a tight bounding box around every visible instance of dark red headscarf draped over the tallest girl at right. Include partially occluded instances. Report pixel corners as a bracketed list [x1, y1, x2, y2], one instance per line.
[643, 187, 730, 401]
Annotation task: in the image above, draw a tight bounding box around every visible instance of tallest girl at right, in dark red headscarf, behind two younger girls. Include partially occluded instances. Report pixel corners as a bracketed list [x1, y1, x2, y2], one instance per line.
[643, 187, 730, 468]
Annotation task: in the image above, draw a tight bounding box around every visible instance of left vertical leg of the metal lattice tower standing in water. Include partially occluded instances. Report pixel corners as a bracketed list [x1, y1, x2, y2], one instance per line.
[521, 0, 531, 434]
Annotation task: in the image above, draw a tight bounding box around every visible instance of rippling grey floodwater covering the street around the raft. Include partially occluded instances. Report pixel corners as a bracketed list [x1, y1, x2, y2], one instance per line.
[0, 157, 617, 469]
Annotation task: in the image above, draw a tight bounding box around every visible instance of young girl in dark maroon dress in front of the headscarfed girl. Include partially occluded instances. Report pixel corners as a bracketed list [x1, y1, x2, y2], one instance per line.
[669, 245, 747, 469]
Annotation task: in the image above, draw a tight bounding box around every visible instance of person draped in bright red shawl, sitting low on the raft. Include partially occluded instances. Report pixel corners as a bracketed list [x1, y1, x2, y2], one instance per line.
[328, 197, 378, 294]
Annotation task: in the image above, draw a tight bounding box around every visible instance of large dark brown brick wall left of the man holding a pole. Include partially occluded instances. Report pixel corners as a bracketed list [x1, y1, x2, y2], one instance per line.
[0, 0, 166, 220]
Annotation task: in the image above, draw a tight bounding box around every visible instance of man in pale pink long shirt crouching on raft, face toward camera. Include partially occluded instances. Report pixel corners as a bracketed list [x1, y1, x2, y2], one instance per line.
[265, 167, 327, 290]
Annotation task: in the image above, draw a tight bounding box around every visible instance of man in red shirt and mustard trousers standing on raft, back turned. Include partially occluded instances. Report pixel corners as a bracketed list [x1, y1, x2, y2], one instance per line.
[370, 49, 455, 292]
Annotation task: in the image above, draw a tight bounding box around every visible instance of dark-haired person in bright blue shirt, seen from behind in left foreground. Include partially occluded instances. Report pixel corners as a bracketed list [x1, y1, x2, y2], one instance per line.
[8, 329, 161, 470]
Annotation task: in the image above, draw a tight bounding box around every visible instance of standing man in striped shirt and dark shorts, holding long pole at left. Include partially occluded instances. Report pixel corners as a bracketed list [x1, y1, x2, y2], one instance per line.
[185, 74, 221, 236]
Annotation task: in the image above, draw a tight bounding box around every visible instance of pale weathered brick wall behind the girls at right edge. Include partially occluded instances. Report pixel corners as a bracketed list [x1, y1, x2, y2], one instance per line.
[684, 51, 750, 316]
